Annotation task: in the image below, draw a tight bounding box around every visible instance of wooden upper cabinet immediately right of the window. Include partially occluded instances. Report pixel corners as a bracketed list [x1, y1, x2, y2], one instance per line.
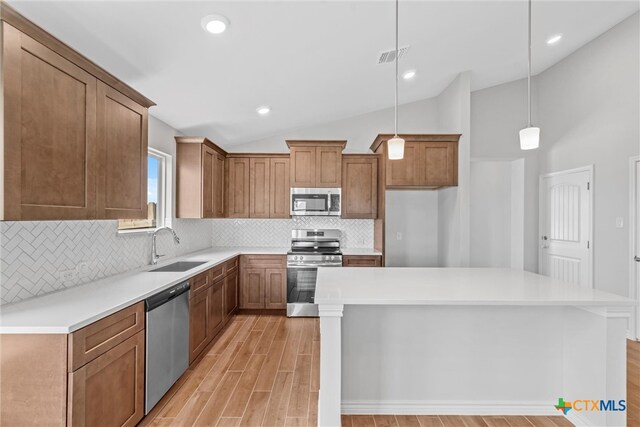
[175, 136, 226, 218]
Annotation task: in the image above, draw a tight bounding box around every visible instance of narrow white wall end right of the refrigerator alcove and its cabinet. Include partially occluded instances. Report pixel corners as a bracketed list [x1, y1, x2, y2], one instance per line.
[436, 72, 471, 267]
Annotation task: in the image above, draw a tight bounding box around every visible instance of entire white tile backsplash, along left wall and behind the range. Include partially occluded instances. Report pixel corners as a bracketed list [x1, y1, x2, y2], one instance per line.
[0, 217, 373, 304]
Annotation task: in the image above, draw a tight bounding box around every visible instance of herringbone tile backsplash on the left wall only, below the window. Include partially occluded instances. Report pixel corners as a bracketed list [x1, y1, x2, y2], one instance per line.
[0, 220, 212, 304]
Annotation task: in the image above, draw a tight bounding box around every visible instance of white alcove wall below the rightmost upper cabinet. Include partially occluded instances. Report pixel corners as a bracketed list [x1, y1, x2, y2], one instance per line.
[385, 190, 438, 267]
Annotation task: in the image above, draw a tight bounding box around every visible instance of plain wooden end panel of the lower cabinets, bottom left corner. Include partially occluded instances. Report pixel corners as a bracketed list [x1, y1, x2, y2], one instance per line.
[0, 334, 67, 426]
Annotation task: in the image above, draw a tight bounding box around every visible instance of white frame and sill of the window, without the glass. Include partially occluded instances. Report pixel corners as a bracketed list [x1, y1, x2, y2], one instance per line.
[117, 147, 173, 235]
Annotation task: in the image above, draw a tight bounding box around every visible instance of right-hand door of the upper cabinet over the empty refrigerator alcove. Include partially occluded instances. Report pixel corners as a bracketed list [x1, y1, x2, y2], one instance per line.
[420, 142, 458, 186]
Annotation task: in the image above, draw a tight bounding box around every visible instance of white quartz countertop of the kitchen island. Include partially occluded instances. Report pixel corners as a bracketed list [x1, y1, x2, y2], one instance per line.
[315, 267, 635, 307]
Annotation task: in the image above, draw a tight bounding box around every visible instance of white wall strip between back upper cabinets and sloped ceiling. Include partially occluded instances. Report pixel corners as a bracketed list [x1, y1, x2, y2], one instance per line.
[230, 98, 438, 153]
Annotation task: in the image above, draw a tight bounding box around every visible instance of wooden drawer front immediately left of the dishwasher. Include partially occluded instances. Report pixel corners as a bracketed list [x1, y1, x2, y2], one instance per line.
[68, 302, 144, 372]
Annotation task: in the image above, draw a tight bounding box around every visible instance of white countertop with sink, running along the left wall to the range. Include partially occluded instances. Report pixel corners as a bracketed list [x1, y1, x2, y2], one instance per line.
[0, 247, 289, 334]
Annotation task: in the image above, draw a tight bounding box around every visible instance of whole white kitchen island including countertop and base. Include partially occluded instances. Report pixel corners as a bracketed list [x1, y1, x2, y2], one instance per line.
[315, 268, 634, 426]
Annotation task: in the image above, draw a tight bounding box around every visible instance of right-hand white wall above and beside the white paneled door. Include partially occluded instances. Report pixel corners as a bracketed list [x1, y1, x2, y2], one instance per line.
[538, 13, 640, 295]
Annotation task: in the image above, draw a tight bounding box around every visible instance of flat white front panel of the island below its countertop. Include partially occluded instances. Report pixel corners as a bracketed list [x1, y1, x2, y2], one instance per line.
[342, 305, 563, 415]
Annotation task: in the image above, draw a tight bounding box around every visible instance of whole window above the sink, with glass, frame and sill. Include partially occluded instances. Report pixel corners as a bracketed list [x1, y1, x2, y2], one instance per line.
[118, 148, 172, 232]
